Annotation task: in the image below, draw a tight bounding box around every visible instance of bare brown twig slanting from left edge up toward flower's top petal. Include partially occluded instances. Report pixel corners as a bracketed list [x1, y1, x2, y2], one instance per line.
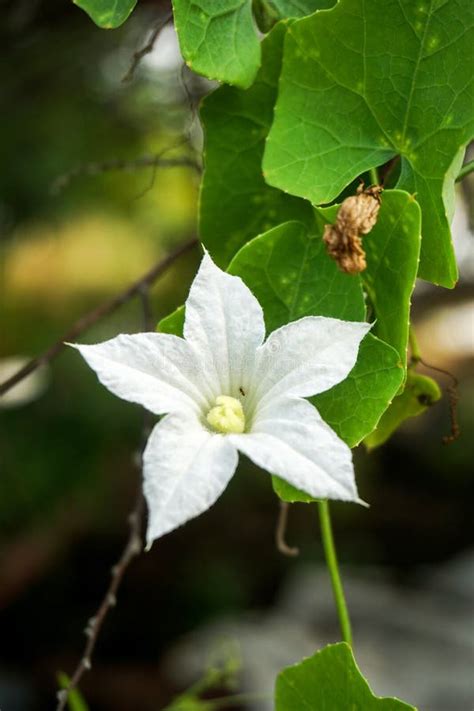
[0, 238, 198, 396]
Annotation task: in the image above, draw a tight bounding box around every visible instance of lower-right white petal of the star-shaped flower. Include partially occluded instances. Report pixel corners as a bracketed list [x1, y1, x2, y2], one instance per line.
[229, 397, 360, 502]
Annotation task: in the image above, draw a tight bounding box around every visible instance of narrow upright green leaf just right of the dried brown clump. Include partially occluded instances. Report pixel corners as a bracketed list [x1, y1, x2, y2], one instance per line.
[318, 190, 421, 367]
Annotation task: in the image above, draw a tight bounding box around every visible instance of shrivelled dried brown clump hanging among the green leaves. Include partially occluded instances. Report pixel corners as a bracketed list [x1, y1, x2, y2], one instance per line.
[323, 185, 383, 274]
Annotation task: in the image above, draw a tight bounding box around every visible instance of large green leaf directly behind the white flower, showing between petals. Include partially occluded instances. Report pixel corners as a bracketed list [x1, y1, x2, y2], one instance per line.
[228, 221, 404, 502]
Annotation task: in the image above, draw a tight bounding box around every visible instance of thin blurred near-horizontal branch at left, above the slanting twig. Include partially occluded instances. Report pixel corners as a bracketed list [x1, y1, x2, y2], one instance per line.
[51, 155, 202, 195]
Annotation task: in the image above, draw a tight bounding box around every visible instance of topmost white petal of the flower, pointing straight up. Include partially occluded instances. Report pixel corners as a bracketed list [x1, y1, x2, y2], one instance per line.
[184, 253, 265, 396]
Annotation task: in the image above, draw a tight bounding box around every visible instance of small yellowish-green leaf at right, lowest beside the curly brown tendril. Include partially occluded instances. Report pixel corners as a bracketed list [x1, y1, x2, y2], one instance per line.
[364, 370, 441, 450]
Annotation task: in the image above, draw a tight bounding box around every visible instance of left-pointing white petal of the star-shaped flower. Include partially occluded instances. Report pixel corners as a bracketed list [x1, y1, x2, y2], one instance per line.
[70, 333, 213, 415]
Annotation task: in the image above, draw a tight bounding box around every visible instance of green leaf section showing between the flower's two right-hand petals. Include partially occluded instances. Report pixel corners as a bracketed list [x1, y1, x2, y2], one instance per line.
[310, 333, 405, 447]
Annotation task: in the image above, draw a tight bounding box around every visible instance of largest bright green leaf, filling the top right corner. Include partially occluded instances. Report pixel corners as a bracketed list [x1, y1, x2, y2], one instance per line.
[264, 0, 474, 287]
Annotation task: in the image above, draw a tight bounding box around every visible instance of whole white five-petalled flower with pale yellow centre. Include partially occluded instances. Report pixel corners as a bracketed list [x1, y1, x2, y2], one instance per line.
[69, 254, 370, 545]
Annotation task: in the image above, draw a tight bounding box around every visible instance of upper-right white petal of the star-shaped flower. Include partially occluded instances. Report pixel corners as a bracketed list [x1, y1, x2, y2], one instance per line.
[254, 316, 371, 401]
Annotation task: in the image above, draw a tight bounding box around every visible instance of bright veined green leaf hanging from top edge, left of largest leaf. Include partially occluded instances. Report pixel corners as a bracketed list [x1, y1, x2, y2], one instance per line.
[173, 0, 260, 87]
